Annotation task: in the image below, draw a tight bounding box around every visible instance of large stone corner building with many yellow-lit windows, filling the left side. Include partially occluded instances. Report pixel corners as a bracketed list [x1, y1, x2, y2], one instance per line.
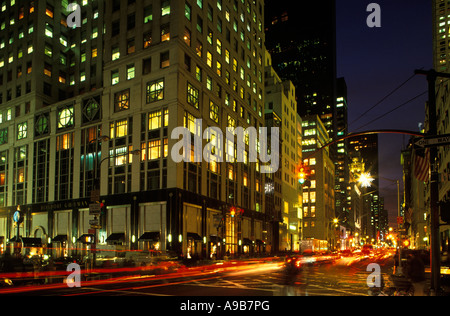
[0, 0, 272, 257]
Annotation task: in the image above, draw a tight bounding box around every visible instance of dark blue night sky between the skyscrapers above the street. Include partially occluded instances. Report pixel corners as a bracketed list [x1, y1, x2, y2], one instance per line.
[336, 0, 433, 225]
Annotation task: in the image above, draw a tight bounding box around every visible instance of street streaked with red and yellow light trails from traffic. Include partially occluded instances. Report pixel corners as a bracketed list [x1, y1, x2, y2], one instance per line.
[0, 253, 400, 297]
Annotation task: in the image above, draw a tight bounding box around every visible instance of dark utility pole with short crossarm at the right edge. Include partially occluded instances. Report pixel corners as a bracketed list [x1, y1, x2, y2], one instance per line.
[415, 69, 450, 294]
